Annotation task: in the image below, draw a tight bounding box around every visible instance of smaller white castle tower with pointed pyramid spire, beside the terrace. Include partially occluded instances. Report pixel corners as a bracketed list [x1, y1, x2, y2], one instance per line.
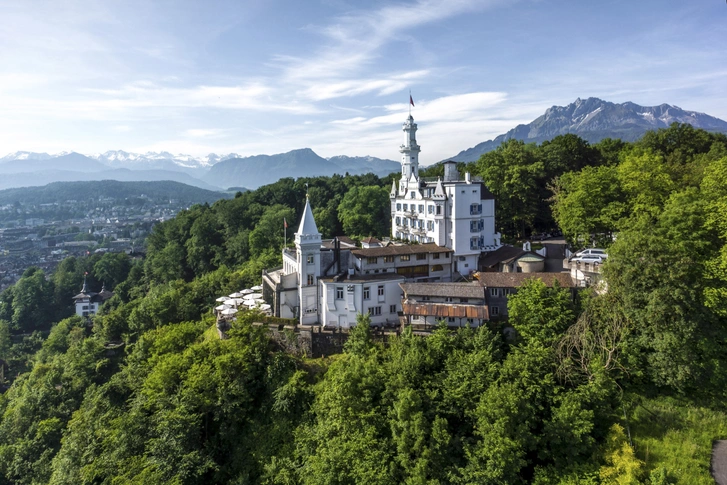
[295, 197, 321, 324]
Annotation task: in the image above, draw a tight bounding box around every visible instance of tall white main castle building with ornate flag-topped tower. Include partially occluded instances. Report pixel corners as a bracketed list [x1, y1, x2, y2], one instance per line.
[390, 115, 500, 275]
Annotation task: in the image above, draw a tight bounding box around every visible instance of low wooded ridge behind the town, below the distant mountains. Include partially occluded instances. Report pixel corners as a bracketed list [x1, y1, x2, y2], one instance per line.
[0, 180, 229, 205]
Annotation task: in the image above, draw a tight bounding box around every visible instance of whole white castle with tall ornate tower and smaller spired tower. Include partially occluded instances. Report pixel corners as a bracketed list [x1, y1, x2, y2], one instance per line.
[263, 114, 501, 328]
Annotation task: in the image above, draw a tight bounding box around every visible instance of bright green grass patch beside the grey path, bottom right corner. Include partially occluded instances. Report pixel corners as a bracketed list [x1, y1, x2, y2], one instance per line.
[629, 397, 727, 485]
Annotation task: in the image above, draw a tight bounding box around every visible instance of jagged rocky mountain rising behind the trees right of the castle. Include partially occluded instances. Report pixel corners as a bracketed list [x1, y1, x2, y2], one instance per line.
[447, 98, 727, 162]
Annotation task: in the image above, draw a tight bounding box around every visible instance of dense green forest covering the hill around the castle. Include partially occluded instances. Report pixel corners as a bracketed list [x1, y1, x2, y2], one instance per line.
[0, 125, 727, 485]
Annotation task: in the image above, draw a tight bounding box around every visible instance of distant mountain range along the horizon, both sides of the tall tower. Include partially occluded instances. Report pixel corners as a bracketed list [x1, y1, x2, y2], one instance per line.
[0, 98, 727, 190]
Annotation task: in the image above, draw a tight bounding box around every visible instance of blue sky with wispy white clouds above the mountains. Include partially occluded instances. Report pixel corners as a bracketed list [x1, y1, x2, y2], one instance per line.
[0, 0, 727, 165]
